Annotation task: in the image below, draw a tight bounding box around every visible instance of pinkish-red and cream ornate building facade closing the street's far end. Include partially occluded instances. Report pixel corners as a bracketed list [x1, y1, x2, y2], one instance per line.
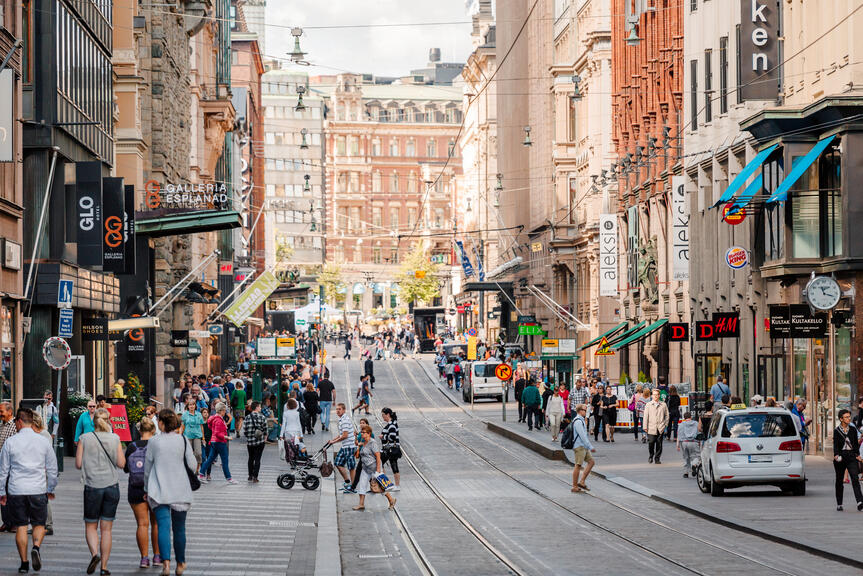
[320, 74, 462, 314]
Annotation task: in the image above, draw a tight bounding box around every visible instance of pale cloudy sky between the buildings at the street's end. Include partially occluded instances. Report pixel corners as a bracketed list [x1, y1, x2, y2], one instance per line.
[266, 0, 471, 76]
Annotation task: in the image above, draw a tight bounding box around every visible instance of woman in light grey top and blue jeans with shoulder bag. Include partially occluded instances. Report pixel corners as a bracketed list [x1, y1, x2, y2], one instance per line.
[144, 409, 198, 576]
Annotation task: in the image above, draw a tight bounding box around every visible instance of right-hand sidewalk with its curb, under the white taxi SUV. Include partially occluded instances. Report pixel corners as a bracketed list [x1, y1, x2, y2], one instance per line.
[421, 358, 863, 568]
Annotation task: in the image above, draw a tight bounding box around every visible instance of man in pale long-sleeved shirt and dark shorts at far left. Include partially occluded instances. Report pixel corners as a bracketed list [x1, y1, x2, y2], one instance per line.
[0, 408, 57, 573]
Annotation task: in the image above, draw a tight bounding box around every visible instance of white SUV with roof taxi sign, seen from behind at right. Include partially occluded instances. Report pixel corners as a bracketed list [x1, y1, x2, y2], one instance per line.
[696, 408, 806, 496]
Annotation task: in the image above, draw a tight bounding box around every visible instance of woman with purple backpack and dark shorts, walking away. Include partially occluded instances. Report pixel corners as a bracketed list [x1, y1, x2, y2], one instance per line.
[123, 418, 162, 568]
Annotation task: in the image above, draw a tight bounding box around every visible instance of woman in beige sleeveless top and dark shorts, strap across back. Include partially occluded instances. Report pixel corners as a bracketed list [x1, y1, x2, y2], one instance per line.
[75, 408, 126, 576]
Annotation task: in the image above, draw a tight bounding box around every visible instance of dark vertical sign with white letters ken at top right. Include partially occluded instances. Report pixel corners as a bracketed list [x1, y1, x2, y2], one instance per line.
[737, 0, 779, 100]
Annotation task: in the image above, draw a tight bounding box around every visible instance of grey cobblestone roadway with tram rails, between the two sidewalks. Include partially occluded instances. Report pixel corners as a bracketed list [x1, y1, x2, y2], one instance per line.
[333, 360, 848, 574]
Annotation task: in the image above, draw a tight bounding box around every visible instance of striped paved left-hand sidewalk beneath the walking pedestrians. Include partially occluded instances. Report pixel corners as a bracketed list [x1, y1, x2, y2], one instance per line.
[0, 436, 323, 576]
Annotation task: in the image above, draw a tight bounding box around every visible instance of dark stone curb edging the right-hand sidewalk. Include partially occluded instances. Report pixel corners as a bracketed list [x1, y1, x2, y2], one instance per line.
[483, 420, 863, 569]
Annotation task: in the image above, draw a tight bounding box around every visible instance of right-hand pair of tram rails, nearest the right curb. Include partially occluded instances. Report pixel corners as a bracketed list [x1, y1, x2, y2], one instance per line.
[387, 360, 797, 576]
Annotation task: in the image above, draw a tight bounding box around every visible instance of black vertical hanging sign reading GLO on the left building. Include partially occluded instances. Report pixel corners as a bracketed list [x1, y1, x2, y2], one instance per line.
[75, 162, 103, 268]
